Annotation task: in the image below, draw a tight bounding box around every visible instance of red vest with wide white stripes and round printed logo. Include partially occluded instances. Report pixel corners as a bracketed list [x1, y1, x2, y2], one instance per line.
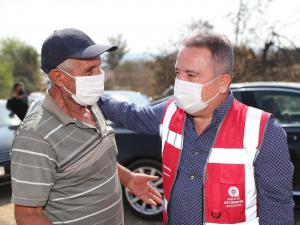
[160, 100, 270, 225]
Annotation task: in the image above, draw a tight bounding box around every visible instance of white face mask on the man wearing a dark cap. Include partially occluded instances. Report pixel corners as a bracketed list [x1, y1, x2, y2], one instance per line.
[58, 68, 104, 106]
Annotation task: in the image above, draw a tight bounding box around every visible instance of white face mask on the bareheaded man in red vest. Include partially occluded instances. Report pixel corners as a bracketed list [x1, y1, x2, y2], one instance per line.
[174, 77, 219, 114]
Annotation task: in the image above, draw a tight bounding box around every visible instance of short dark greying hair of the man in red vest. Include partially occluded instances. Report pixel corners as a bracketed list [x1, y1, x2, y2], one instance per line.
[183, 33, 234, 75]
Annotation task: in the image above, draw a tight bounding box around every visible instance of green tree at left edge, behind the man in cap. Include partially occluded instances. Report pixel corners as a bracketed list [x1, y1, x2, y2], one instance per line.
[0, 38, 41, 92]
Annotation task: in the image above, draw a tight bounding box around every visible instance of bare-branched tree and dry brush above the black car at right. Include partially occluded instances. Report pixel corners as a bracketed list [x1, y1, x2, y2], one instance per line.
[227, 0, 300, 82]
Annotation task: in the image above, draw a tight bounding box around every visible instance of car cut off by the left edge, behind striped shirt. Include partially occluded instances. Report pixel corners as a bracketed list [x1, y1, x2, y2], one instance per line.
[0, 99, 21, 186]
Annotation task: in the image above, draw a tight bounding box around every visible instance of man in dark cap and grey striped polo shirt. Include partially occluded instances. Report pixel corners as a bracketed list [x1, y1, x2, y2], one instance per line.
[11, 28, 160, 225]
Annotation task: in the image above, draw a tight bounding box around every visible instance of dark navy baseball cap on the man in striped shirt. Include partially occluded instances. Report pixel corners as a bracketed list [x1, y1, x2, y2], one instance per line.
[41, 28, 118, 73]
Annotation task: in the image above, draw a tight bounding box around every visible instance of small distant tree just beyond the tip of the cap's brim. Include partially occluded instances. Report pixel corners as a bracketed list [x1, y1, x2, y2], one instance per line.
[104, 34, 129, 70]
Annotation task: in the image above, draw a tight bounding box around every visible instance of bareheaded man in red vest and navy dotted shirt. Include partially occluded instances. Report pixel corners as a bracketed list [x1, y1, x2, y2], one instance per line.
[99, 33, 294, 225]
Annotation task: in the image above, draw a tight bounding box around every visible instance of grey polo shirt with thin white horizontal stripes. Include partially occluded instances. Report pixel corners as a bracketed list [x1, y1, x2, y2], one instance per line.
[11, 93, 124, 225]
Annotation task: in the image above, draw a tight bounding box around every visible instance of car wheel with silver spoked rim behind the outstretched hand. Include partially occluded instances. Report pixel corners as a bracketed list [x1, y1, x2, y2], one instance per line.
[123, 159, 163, 219]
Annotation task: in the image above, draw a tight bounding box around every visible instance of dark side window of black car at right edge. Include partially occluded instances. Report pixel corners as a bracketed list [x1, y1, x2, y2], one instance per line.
[253, 91, 300, 124]
